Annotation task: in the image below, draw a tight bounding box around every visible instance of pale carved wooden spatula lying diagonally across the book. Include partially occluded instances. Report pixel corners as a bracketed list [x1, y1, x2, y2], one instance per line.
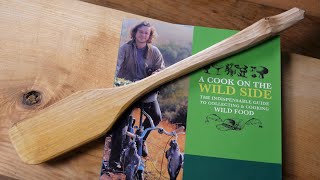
[9, 8, 304, 164]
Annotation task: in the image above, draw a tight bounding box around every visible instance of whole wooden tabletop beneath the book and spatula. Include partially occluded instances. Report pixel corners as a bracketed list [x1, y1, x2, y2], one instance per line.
[0, 0, 320, 179]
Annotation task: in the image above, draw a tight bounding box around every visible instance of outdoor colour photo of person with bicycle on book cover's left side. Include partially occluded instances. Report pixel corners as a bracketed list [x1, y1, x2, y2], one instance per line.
[100, 19, 193, 180]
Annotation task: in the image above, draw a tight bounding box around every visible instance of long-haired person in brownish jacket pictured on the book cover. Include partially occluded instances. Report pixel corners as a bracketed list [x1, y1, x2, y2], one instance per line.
[109, 21, 165, 169]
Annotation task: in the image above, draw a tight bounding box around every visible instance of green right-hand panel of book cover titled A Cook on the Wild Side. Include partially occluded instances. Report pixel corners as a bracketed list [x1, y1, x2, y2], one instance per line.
[183, 27, 282, 180]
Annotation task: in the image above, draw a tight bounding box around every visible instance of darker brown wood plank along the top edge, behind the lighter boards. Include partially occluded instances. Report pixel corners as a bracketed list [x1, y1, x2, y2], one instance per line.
[84, 0, 320, 59]
